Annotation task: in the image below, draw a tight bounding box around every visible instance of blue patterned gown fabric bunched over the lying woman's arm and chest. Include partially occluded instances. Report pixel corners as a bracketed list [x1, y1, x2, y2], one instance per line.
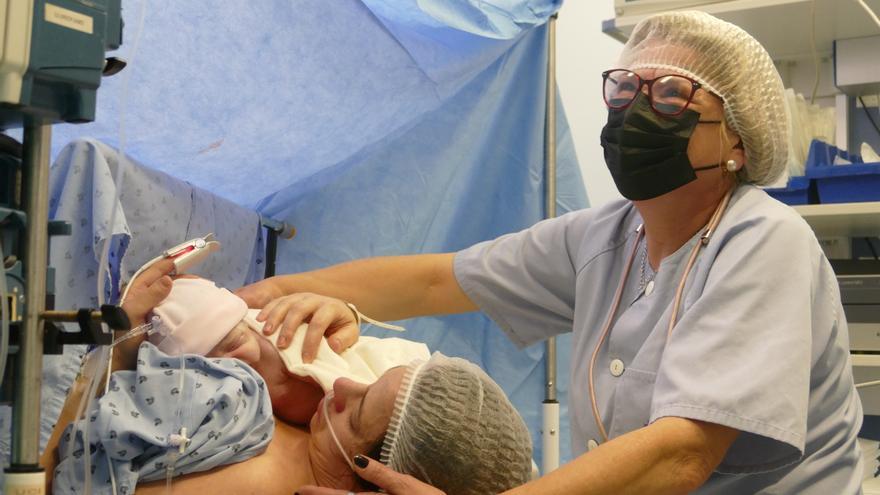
[53, 342, 275, 495]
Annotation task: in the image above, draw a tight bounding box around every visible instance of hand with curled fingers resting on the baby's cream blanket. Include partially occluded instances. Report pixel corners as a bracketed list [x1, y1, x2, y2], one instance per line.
[257, 292, 360, 363]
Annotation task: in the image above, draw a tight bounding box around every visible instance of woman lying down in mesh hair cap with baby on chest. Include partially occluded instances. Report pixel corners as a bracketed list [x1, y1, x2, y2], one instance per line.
[42, 262, 531, 495]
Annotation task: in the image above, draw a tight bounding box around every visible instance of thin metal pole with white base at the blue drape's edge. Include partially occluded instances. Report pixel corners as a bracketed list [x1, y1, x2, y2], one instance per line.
[541, 14, 559, 475]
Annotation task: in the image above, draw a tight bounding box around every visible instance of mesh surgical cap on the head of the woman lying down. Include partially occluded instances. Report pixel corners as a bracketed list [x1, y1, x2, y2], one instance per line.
[380, 353, 532, 494]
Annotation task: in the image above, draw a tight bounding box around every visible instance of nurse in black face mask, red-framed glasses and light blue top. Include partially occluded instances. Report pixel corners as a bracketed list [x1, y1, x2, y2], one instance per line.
[240, 12, 862, 495]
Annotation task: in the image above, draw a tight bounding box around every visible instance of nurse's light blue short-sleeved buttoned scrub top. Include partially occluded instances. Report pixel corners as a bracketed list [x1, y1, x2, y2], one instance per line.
[455, 186, 862, 495]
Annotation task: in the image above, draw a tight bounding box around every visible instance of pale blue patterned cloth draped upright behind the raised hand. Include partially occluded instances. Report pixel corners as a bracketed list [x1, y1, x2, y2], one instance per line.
[40, 139, 265, 458]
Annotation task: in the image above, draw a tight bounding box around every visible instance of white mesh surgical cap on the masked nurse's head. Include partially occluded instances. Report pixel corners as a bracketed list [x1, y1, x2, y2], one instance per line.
[620, 11, 790, 185]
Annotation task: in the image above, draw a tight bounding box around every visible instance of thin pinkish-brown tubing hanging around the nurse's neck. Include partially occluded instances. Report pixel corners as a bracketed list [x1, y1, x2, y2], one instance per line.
[590, 188, 733, 442]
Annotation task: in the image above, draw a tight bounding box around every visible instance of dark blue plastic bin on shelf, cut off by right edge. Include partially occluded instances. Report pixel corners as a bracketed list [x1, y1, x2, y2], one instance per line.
[807, 163, 880, 203]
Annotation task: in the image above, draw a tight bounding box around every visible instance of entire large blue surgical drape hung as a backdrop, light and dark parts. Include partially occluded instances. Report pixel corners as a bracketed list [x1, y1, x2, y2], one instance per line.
[41, 0, 587, 468]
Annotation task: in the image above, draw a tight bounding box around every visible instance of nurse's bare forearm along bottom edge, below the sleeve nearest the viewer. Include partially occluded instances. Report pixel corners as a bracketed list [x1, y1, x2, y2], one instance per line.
[505, 417, 739, 495]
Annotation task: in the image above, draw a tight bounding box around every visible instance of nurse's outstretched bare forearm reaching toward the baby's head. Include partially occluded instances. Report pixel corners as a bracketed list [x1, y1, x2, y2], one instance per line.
[272, 253, 477, 320]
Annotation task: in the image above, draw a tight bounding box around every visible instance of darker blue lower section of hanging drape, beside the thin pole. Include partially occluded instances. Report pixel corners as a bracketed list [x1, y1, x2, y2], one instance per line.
[258, 19, 586, 464]
